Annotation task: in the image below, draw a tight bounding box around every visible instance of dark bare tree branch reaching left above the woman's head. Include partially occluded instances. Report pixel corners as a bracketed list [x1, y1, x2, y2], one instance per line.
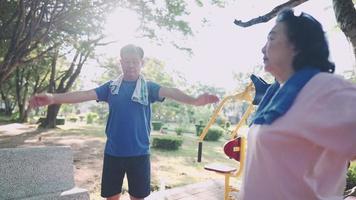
[234, 0, 308, 27]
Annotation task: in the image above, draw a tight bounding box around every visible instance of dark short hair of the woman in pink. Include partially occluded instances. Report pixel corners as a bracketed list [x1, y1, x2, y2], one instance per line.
[276, 9, 335, 73]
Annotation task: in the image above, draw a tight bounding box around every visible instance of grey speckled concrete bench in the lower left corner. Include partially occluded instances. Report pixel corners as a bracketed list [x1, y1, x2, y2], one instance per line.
[0, 146, 89, 200]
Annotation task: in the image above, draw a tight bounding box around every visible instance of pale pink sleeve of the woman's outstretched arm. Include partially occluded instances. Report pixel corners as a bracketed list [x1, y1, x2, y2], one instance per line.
[299, 84, 356, 160]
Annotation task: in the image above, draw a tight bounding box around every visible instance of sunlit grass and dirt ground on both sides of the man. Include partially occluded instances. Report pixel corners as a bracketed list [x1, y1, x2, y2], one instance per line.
[0, 122, 356, 199]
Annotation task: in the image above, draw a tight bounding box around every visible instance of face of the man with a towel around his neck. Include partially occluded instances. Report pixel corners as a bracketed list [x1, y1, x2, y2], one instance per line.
[120, 54, 143, 81]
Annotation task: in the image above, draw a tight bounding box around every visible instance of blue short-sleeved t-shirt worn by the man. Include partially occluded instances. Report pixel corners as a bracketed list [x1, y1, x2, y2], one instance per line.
[95, 80, 163, 157]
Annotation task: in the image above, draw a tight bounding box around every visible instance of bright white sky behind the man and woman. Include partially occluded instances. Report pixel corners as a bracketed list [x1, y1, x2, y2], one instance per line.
[83, 0, 355, 91]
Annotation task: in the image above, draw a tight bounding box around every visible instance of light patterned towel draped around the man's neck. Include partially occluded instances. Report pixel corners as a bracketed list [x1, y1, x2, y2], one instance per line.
[109, 75, 148, 106]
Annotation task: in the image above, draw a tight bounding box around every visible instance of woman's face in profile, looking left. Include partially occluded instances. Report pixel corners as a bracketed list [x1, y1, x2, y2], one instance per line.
[262, 22, 296, 83]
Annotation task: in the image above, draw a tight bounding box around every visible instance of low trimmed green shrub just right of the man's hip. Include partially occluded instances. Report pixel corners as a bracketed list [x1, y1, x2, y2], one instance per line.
[152, 135, 183, 150]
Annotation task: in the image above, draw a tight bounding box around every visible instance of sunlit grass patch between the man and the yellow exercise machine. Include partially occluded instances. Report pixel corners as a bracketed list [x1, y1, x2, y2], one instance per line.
[151, 133, 237, 188]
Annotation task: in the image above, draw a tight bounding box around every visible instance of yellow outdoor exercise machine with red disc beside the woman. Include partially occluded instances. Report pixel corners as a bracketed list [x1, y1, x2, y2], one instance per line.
[198, 75, 269, 200]
